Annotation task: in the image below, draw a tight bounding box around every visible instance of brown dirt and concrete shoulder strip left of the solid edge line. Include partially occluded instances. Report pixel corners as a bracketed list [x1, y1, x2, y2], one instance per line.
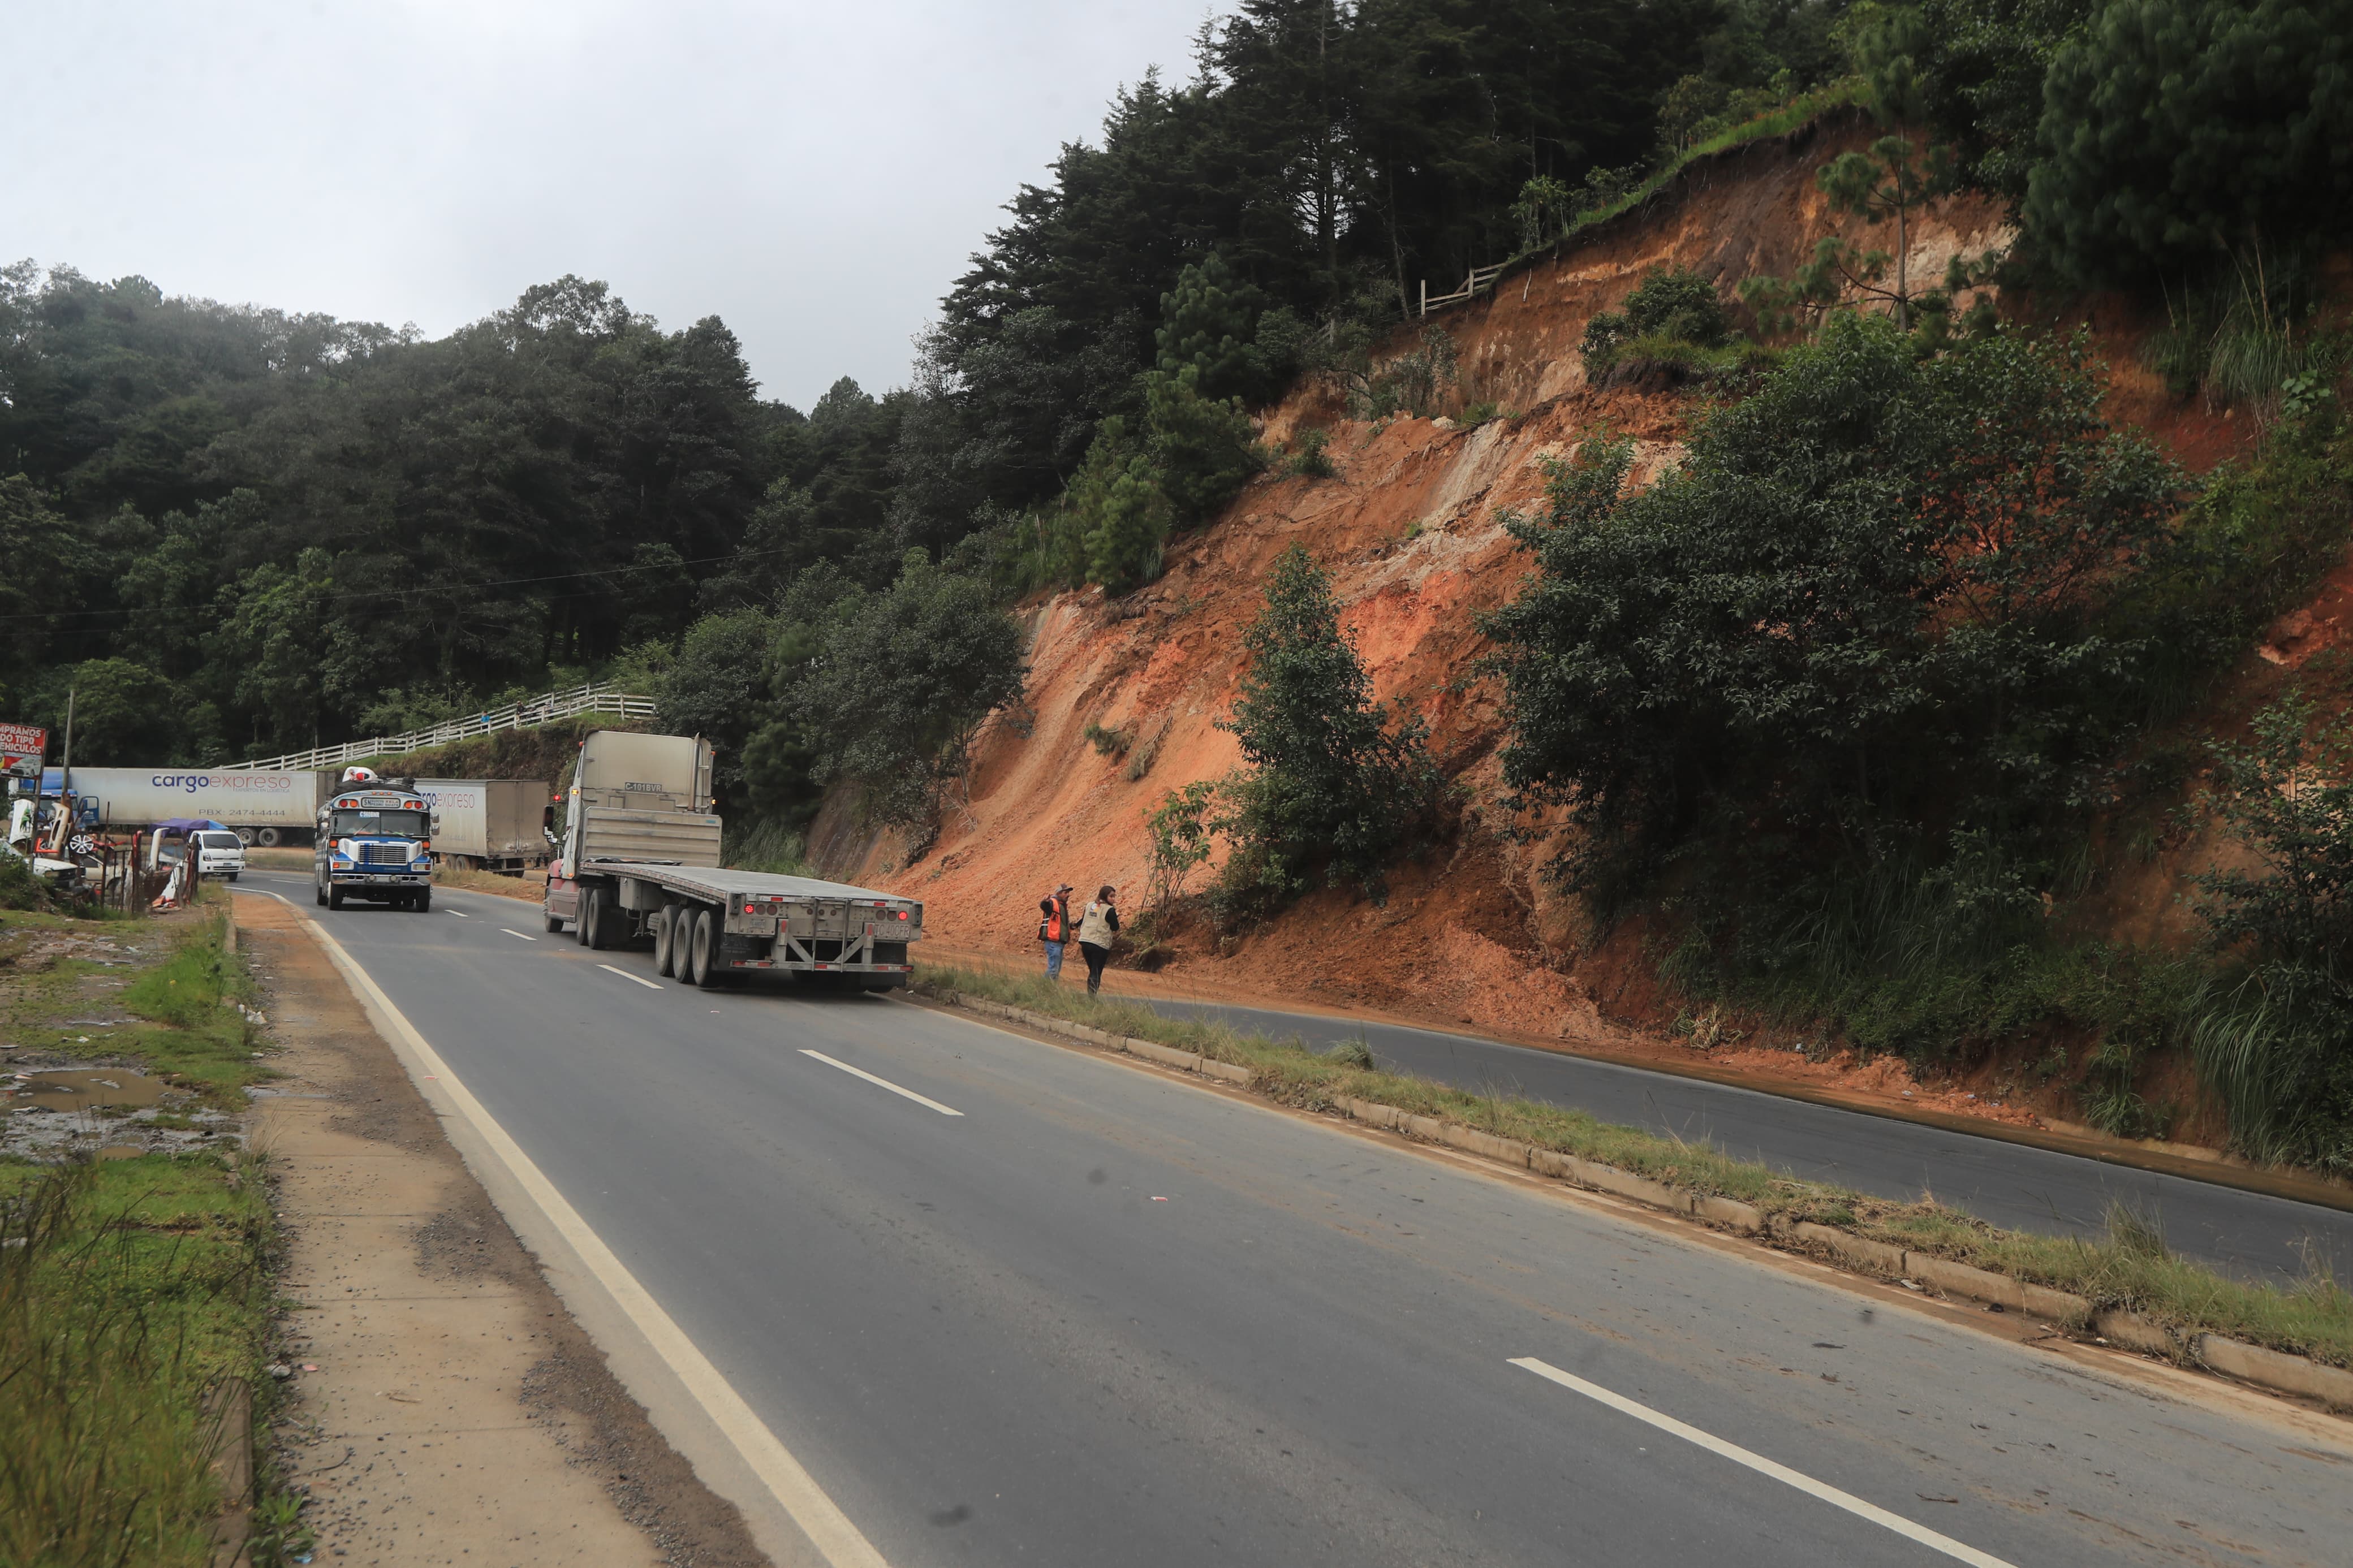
[238, 896, 767, 1568]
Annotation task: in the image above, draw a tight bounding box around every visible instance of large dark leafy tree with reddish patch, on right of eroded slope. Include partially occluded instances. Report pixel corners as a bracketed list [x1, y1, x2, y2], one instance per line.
[1485, 317, 2181, 893]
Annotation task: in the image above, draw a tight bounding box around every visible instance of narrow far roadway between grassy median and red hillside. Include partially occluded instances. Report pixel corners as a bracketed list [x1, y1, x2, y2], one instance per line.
[1127, 997, 2353, 1279]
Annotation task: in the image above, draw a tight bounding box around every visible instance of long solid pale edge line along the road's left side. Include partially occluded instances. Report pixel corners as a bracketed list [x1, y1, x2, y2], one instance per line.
[280, 889, 889, 1568]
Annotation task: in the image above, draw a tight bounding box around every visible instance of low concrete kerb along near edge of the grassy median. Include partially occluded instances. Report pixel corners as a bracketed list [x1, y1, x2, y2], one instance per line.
[955, 992, 2353, 1410]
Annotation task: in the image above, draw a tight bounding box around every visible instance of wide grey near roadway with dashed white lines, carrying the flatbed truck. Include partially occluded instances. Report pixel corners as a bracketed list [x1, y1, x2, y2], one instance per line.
[247, 875, 2353, 1568]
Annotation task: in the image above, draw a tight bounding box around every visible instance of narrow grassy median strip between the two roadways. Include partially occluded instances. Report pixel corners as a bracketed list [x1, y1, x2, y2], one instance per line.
[915, 964, 2353, 1366]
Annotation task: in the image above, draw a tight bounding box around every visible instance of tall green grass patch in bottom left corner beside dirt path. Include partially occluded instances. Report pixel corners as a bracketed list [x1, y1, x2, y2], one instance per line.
[0, 1154, 275, 1568]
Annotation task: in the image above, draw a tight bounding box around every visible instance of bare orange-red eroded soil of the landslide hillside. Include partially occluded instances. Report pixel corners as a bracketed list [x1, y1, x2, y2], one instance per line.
[812, 107, 2346, 1142]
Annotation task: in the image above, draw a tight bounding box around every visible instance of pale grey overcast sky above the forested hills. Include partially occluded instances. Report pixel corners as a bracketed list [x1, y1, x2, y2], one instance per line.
[14, 0, 1209, 407]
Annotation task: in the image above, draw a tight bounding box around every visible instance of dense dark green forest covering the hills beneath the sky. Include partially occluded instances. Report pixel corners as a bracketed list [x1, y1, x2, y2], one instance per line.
[0, 0, 2353, 816]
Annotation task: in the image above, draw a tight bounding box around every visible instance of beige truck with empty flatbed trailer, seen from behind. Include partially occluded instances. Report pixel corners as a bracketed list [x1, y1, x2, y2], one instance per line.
[544, 729, 923, 990]
